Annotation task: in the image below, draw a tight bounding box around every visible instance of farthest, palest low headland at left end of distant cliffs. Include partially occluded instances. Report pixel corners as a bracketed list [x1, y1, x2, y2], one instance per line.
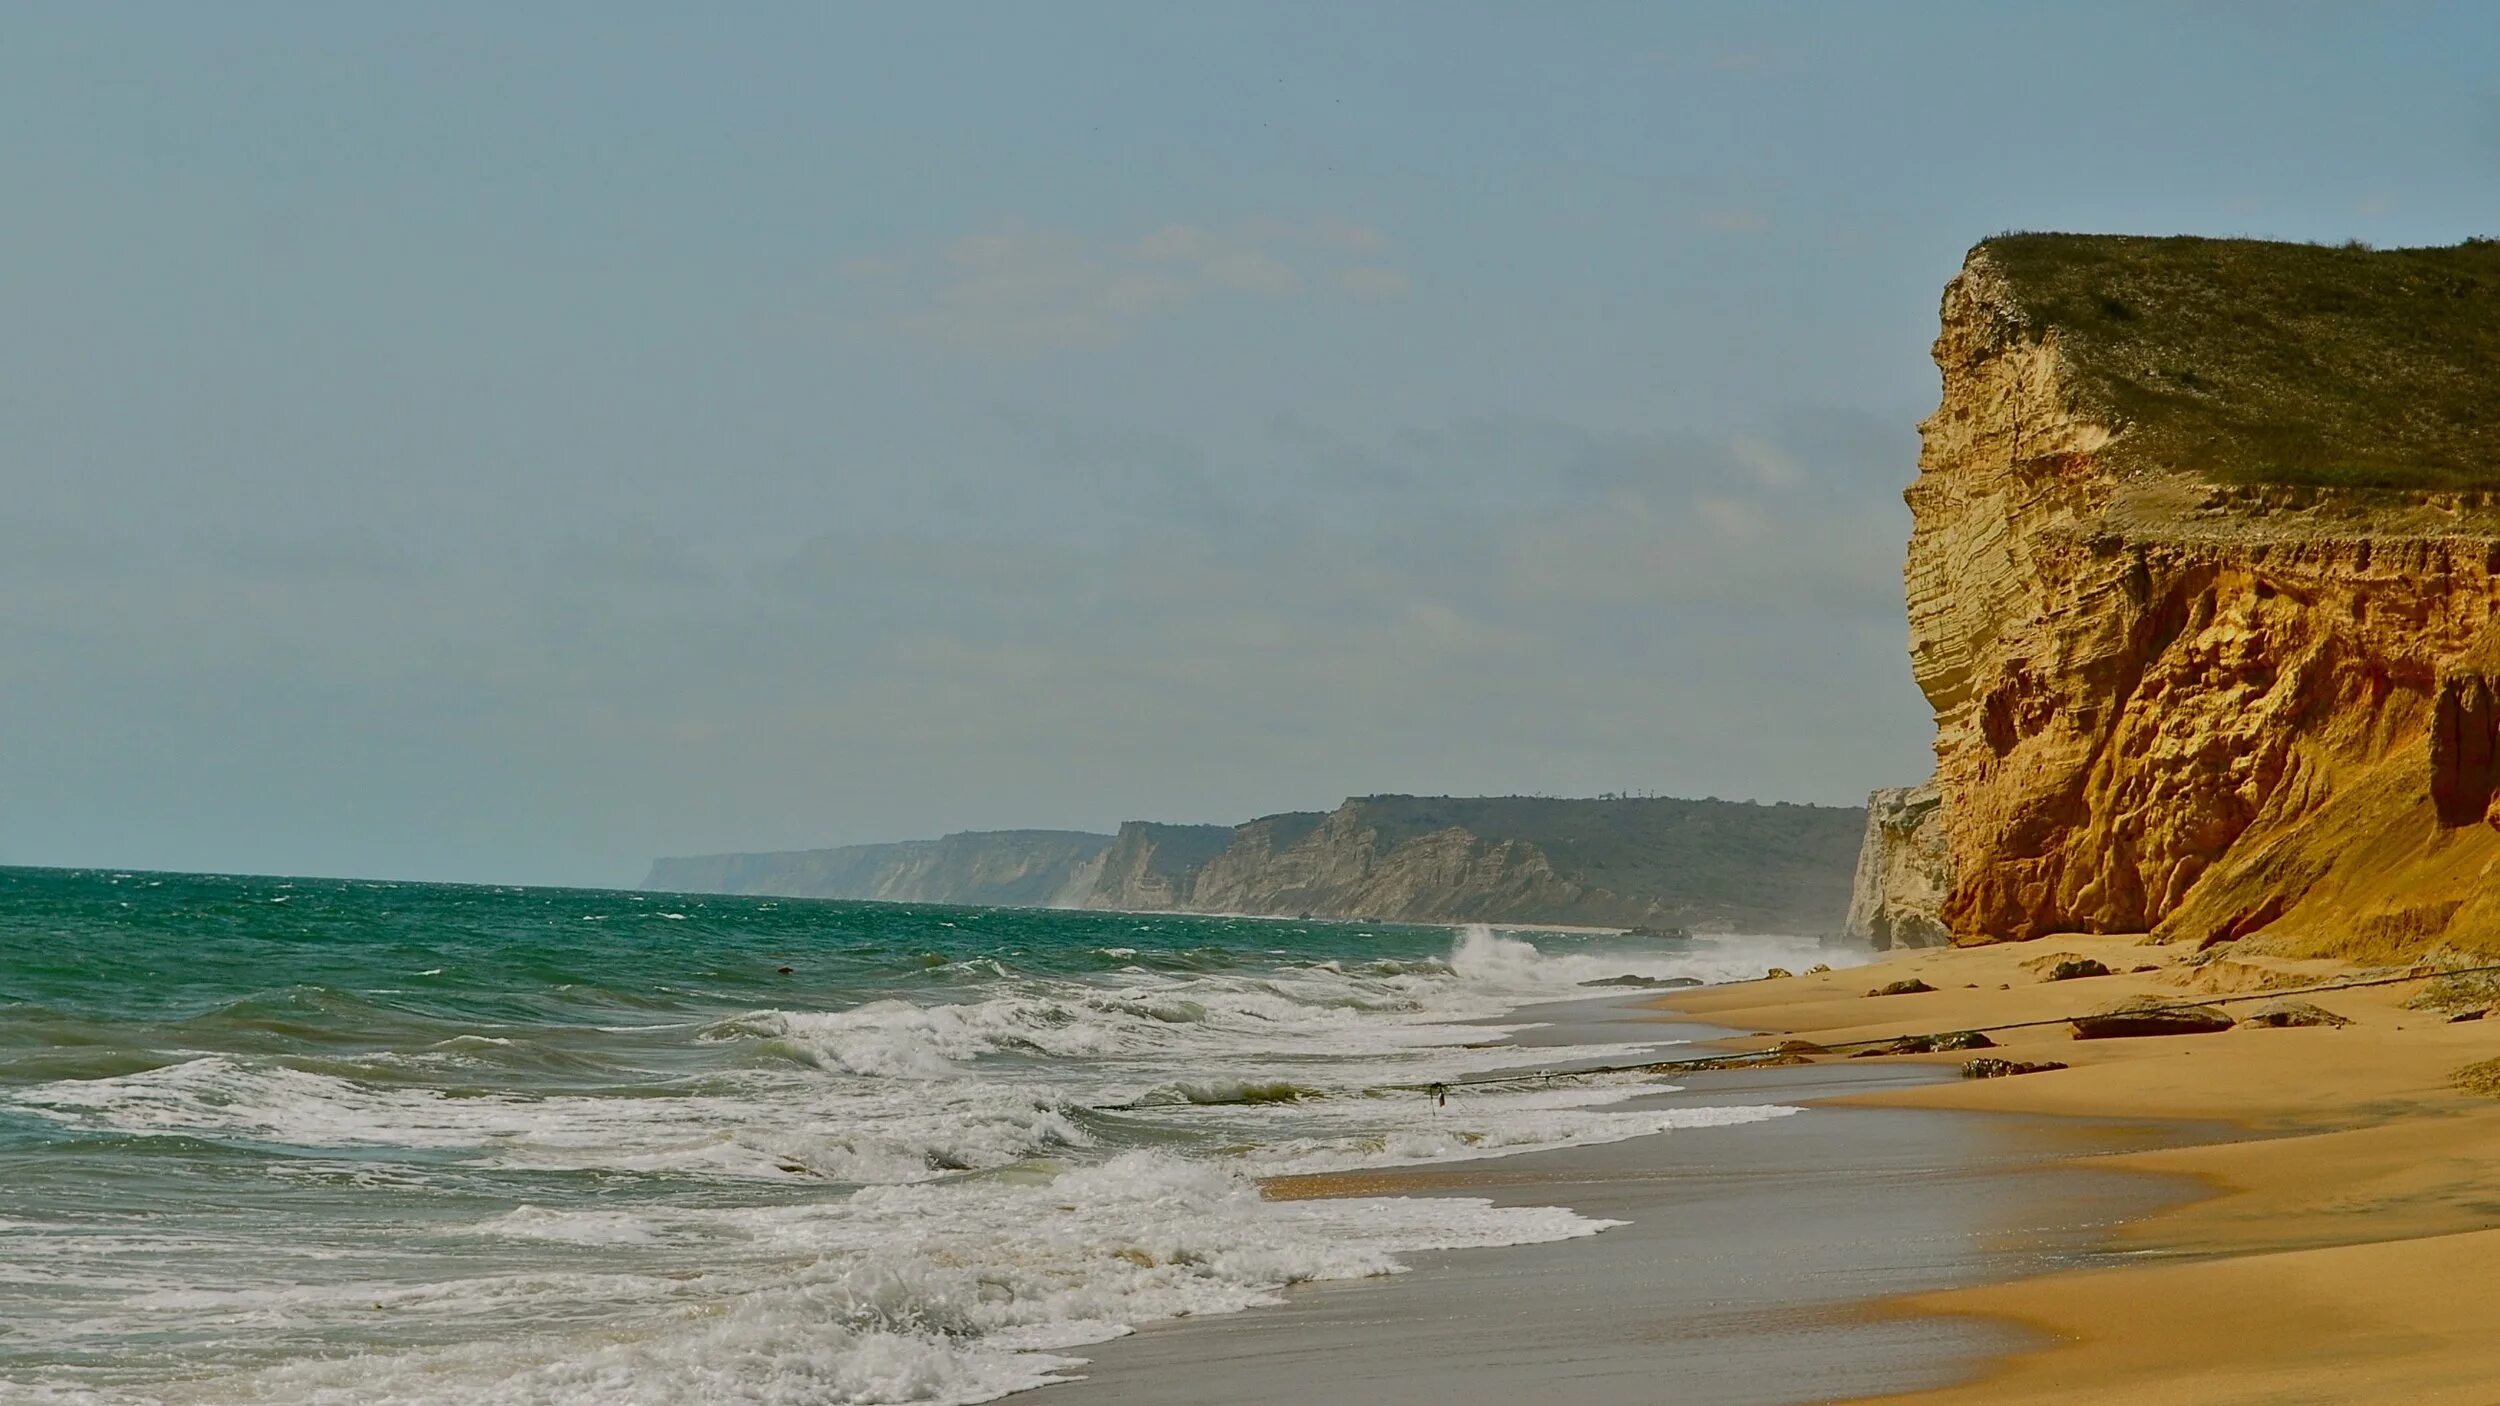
[643, 831, 1110, 908]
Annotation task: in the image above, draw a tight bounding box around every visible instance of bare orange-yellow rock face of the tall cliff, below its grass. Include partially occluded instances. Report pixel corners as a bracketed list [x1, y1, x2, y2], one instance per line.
[1905, 245, 2500, 958]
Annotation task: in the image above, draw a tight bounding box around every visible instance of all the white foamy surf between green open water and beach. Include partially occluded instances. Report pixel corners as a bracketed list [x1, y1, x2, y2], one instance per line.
[0, 923, 1860, 1406]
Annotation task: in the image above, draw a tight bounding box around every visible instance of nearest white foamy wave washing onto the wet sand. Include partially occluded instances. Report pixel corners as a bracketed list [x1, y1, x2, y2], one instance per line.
[97, 1151, 1613, 1406]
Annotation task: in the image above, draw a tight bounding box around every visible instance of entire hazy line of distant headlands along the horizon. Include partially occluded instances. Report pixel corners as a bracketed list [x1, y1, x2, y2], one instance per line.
[643, 796, 1865, 933]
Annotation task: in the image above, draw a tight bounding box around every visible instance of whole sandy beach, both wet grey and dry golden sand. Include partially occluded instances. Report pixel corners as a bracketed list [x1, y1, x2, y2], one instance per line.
[1053, 936, 2500, 1406]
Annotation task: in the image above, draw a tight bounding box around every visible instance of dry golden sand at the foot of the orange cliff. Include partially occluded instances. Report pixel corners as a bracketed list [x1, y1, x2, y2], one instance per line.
[1650, 936, 2500, 1406]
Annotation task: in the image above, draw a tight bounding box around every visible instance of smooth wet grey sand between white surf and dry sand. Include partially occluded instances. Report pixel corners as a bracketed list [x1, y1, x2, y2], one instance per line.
[1045, 993, 2190, 1406]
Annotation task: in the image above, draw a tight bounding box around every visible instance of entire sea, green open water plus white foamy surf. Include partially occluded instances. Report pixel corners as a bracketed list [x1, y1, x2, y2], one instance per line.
[0, 868, 1833, 1406]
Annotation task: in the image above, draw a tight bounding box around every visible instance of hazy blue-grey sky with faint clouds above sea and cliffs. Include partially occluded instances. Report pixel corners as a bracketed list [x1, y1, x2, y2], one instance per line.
[0, 0, 2500, 886]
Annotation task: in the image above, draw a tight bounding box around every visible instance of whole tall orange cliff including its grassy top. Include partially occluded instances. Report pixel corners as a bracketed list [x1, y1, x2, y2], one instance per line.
[1905, 235, 2500, 961]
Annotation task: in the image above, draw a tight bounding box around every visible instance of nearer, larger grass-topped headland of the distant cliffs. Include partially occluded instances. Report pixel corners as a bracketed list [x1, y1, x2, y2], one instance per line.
[1088, 796, 1863, 933]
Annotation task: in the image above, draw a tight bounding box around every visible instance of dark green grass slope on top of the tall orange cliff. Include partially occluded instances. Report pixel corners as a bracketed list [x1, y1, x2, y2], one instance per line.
[1980, 235, 2500, 490]
